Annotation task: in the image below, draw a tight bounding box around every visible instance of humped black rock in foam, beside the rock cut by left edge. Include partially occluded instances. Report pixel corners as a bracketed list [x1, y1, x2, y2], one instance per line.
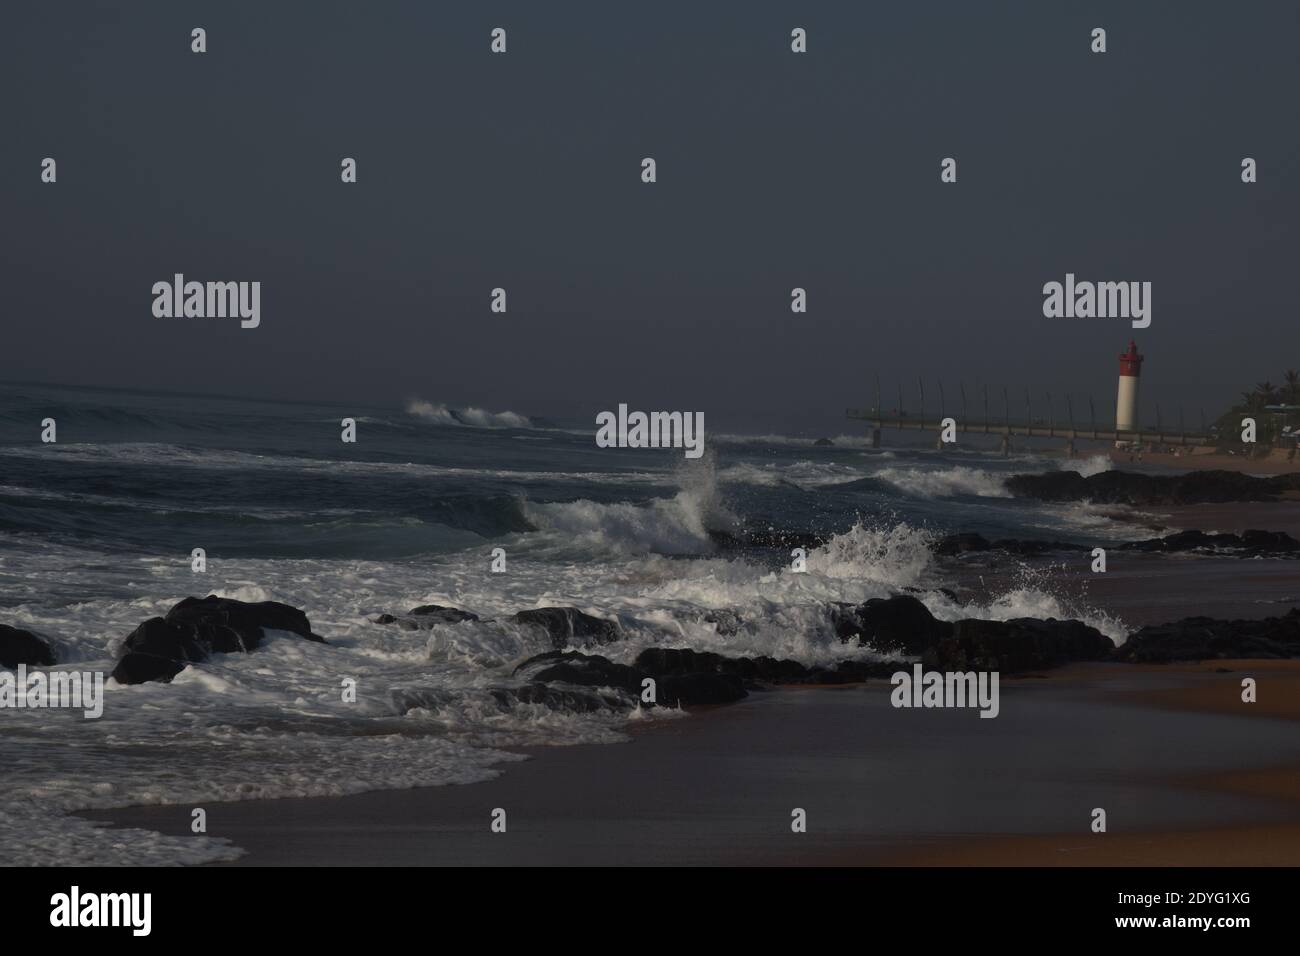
[113, 594, 325, 684]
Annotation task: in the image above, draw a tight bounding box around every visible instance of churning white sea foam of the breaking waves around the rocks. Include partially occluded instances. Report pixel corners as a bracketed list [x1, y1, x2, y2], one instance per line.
[0, 423, 1149, 864]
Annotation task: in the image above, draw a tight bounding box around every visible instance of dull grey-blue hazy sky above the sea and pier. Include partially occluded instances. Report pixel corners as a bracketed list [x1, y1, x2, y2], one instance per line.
[0, 0, 1300, 434]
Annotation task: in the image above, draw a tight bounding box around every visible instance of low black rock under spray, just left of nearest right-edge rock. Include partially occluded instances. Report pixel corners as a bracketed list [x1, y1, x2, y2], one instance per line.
[922, 618, 1115, 674]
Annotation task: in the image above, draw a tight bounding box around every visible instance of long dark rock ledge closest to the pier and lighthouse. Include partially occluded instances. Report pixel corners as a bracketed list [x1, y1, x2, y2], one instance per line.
[1006, 471, 1300, 505]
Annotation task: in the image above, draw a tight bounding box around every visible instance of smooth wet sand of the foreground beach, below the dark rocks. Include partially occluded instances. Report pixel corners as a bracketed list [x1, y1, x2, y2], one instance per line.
[85, 662, 1300, 865]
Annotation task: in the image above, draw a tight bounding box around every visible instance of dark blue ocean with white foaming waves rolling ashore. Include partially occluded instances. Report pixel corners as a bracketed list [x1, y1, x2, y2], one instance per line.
[0, 384, 1132, 864]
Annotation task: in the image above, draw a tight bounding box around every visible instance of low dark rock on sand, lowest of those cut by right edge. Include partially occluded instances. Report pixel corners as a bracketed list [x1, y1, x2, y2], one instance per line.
[1114, 607, 1300, 663]
